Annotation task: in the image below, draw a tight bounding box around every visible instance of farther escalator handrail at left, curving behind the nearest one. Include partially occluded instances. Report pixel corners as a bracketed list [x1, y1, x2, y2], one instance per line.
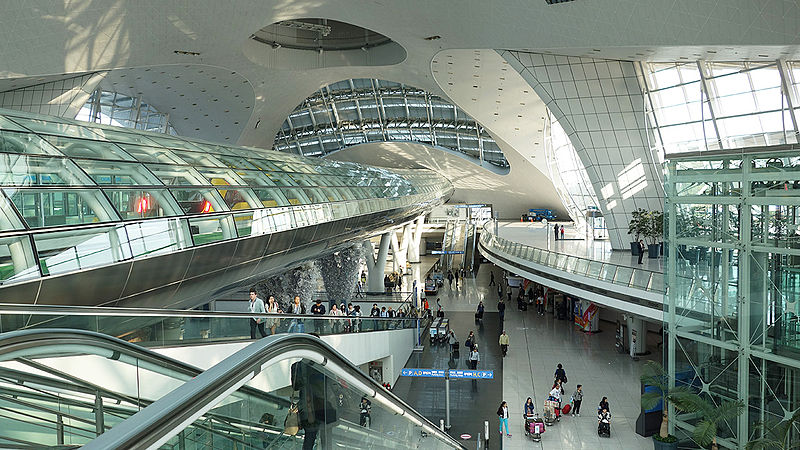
[0, 328, 288, 405]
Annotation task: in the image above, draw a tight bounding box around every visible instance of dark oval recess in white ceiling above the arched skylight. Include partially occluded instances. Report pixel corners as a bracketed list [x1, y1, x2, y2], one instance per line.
[251, 18, 392, 51]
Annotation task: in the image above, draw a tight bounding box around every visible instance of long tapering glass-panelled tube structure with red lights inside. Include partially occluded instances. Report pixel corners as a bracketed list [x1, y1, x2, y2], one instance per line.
[0, 110, 452, 285]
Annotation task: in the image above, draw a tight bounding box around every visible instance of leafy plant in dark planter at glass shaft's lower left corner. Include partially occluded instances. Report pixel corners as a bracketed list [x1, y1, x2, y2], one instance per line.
[641, 361, 691, 450]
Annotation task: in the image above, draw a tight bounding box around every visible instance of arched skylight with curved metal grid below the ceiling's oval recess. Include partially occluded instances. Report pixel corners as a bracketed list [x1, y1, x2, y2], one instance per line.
[273, 78, 508, 167]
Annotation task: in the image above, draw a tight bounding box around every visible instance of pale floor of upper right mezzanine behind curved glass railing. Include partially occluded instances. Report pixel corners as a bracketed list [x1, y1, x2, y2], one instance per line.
[498, 221, 666, 273]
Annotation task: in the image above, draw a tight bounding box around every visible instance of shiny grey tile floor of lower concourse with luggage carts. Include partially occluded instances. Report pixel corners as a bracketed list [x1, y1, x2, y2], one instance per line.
[416, 258, 661, 450]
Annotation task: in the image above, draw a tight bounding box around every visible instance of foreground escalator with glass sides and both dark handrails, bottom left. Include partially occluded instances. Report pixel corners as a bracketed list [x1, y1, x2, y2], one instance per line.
[0, 330, 460, 449]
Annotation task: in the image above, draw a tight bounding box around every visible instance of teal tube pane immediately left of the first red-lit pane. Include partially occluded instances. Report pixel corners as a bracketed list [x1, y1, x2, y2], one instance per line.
[4, 189, 120, 228]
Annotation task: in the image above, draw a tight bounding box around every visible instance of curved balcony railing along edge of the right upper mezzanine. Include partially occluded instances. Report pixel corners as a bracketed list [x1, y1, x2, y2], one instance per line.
[481, 223, 664, 294]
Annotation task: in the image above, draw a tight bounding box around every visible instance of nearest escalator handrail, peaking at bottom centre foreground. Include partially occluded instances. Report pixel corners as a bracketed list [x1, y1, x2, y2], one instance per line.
[84, 334, 464, 450]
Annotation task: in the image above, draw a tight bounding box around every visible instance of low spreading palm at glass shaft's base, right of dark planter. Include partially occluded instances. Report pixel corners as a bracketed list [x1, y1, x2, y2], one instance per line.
[672, 395, 744, 450]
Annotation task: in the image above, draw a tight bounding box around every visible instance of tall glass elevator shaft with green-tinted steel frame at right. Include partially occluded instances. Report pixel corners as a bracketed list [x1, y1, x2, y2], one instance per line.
[665, 144, 800, 448]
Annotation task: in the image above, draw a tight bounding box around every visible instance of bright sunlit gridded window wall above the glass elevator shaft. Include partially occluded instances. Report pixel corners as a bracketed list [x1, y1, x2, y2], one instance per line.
[640, 61, 800, 155]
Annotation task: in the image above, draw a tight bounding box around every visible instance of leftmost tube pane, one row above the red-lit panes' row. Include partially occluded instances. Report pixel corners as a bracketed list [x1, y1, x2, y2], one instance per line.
[0, 153, 94, 186]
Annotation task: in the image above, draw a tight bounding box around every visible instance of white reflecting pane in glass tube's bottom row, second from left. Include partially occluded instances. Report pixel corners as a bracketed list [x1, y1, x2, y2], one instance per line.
[34, 225, 131, 275]
